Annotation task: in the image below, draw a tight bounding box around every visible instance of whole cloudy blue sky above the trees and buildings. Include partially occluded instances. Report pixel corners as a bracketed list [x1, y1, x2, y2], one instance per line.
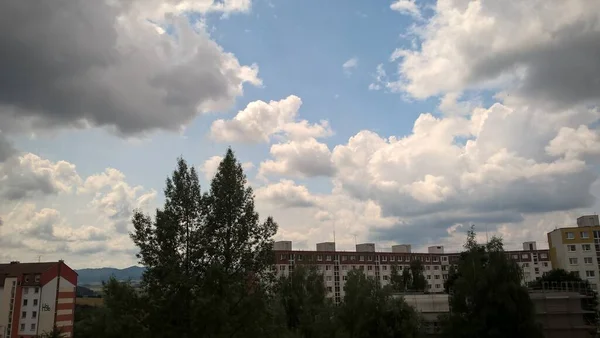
[0, 0, 600, 268]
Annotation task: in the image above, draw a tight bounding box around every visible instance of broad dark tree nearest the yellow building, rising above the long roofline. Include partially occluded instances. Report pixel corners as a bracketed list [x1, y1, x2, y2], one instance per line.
[442, 227, 543, 338]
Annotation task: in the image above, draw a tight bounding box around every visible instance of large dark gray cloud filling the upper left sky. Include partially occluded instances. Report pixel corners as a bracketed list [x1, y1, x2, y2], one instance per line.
[0, 0, 258, 134]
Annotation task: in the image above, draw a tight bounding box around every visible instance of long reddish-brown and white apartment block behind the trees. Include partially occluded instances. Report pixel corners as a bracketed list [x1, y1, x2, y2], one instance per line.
[274, 241, 552, 303]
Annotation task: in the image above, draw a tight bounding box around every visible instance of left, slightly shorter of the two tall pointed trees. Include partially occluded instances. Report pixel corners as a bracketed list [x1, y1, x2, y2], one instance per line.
[131, 158, 207, 337]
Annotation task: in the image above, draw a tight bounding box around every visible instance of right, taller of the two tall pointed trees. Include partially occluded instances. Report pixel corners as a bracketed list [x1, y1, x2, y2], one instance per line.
[195, 149, 277, 337]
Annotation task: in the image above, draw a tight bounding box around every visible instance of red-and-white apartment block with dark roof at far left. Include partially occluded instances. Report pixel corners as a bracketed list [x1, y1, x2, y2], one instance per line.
[0, 260, 77, 338]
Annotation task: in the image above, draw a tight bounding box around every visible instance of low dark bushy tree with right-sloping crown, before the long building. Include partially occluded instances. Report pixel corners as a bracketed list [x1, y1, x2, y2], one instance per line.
[338, 270, 421, 338]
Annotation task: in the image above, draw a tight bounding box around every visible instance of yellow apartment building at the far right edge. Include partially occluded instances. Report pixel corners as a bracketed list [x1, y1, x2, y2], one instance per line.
[548, 215, 600, 289]
